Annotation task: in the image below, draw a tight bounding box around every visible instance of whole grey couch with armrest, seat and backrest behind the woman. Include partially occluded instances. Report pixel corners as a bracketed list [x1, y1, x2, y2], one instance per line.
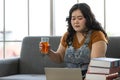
[0, 36, 120, 80]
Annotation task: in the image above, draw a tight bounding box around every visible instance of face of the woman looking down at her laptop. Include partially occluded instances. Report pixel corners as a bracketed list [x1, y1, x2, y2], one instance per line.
[71, 9, 86, 32]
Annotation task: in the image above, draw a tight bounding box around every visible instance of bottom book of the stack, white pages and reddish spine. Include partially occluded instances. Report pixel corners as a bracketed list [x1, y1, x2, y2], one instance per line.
[85, 73, 118, 80]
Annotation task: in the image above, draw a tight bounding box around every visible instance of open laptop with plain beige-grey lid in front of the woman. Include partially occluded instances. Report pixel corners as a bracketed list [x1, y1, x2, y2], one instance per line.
[45, 68, 82, 80]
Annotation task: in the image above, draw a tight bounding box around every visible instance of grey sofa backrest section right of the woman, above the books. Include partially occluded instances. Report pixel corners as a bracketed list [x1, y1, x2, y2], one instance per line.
[106, 37, 120, 58]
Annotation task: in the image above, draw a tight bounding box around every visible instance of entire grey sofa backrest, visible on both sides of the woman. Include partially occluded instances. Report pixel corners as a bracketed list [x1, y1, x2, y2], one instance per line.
[20, 36, 120, 74]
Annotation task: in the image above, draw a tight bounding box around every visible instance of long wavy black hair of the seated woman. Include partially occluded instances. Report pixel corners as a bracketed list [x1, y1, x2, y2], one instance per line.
[66, 3, 107, 45]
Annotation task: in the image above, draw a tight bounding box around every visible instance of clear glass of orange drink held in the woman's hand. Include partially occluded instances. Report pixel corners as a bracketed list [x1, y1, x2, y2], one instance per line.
[41, 37, 49, 54]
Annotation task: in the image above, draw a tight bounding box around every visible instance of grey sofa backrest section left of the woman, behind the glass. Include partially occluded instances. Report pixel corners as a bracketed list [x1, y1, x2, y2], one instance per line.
[20, 36, 65, 74]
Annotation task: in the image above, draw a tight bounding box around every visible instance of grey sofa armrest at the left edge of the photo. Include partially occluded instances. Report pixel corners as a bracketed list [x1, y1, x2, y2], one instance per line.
[0, 58, 20, 77]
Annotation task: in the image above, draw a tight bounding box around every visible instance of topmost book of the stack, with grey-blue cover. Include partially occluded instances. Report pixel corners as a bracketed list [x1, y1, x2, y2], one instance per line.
[89, 57, 120, 67]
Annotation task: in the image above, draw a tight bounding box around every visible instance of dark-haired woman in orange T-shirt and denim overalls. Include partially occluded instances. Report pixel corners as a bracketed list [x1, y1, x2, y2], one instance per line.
[40, 3, 108, 79]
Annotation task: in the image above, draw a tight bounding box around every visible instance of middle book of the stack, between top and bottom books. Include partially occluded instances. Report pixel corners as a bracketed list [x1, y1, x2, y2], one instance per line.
[89, 66, 120, 74]
